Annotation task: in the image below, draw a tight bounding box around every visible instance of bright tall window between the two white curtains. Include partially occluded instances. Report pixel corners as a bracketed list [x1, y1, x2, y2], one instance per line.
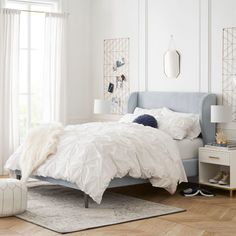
[6, 0, 58, 140]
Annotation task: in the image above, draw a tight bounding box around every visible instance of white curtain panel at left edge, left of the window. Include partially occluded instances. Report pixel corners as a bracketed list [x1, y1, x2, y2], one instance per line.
[0, 9, 20, 175]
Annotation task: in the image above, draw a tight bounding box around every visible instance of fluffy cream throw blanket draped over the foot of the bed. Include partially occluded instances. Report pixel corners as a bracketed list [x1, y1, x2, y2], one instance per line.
[19, 124, 63, 182]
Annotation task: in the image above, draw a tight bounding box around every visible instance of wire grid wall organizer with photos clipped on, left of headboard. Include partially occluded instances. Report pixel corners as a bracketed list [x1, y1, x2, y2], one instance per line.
[103, 38, 130, 114]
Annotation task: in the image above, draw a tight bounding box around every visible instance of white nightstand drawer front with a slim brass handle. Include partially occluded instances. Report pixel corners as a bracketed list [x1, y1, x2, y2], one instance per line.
[199, 150, 230, 166]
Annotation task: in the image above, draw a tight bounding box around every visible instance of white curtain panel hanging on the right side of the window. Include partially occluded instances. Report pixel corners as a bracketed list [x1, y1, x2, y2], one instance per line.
[43, 13, 67, 124]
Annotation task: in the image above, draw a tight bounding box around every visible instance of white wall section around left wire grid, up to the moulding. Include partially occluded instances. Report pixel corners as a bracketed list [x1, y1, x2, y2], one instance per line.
[91, 0, 139, 98]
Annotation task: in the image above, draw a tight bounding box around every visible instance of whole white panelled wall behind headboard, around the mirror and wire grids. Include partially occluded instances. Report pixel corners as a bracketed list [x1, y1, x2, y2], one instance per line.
[87, 0, 236, 136]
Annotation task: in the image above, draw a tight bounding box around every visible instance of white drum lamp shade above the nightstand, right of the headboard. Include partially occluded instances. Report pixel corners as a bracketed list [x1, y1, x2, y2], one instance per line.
[211, 105, 232, 123]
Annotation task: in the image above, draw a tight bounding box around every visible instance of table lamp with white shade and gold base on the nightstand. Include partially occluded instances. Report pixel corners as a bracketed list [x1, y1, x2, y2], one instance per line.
[211, 105, 232, 146]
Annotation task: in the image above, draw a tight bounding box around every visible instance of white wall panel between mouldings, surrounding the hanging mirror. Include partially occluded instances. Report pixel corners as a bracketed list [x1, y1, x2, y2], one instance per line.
[147, 0, 200, 91]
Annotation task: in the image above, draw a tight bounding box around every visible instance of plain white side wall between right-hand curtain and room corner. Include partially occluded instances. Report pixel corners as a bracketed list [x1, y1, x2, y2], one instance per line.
[67, 0, 92, 123]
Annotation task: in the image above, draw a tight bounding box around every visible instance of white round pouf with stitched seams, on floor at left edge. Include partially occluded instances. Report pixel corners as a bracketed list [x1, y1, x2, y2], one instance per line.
[0, 179, 27, 217]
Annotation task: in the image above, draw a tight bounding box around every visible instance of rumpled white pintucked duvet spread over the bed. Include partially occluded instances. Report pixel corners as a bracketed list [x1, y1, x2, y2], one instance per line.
[5, 122, 187, 203]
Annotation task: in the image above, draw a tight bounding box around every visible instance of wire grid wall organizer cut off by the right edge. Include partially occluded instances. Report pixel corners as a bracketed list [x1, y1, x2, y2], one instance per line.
[222, 27, 236, 121]
